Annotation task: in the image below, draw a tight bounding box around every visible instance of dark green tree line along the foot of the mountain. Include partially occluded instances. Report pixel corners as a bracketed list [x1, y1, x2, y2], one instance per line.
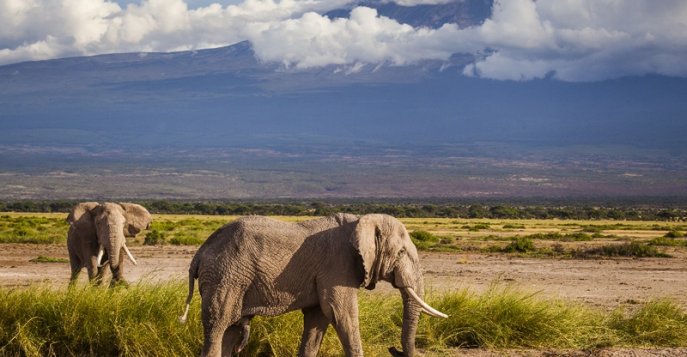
[0, 200, 687, 221]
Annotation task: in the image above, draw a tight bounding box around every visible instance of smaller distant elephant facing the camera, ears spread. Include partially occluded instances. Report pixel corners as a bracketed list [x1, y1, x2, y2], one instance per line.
[67, 202, 152, 286]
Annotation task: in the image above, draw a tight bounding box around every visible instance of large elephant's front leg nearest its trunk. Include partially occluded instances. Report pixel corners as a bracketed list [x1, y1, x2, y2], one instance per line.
[320, 287, 363, 357]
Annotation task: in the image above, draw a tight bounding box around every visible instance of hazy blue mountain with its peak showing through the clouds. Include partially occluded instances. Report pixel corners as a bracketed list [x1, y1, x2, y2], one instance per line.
[0, 0, 687, 198]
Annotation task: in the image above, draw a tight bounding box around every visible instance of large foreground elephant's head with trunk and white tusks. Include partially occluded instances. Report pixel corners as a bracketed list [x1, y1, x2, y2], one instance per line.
[352, 214, 447, 356]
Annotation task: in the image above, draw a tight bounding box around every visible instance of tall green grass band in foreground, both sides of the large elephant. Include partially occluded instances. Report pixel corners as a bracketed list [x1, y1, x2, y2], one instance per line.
[0, 283, 687, 356]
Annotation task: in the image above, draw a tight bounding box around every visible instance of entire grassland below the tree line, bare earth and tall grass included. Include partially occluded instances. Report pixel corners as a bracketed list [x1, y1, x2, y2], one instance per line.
[0, 213, 687, 356]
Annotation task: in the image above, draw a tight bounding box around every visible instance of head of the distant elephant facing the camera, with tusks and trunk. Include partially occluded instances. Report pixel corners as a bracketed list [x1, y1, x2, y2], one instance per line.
[91, 202, 152, 282]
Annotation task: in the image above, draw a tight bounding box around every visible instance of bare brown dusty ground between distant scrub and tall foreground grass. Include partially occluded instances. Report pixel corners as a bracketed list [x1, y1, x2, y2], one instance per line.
[0, 244, 687, 357]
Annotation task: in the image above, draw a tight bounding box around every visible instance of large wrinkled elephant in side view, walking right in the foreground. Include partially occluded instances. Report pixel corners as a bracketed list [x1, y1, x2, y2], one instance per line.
[179, 213, 447, 357]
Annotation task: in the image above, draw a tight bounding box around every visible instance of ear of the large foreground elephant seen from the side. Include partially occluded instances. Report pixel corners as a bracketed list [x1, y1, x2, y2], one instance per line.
[351, 214, 383, 290]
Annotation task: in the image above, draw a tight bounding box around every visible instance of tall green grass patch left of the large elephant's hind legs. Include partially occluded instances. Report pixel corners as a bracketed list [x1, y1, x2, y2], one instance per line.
[0, 284, 202, 356]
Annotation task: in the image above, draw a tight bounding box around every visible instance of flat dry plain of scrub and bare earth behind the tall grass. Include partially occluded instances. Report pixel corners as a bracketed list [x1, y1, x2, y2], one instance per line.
[0, 213, 687, 357]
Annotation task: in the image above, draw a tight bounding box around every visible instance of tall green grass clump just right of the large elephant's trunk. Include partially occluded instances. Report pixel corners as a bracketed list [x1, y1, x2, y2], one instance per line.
[424, 286, 606, 349]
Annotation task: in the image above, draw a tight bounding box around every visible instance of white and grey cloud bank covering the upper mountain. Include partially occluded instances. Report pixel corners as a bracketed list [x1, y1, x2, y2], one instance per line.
[0, 0, 687, 81]
